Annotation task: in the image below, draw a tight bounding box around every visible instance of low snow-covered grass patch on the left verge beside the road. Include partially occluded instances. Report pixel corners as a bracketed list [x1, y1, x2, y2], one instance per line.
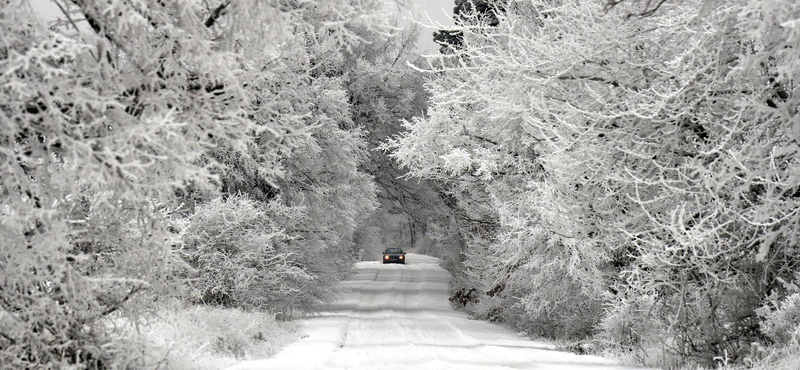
[139, 306, 299, 370]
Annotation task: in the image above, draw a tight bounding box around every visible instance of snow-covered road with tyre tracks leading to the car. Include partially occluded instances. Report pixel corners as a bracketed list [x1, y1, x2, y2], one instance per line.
[227, 254, 648, 370]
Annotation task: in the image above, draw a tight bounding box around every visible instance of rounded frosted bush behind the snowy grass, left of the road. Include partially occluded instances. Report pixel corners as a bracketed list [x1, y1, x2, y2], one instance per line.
[180, 196, 319, 308]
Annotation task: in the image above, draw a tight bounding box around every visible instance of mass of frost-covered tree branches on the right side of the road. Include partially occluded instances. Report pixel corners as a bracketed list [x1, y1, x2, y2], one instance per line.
[387, 0, 800, 362]
